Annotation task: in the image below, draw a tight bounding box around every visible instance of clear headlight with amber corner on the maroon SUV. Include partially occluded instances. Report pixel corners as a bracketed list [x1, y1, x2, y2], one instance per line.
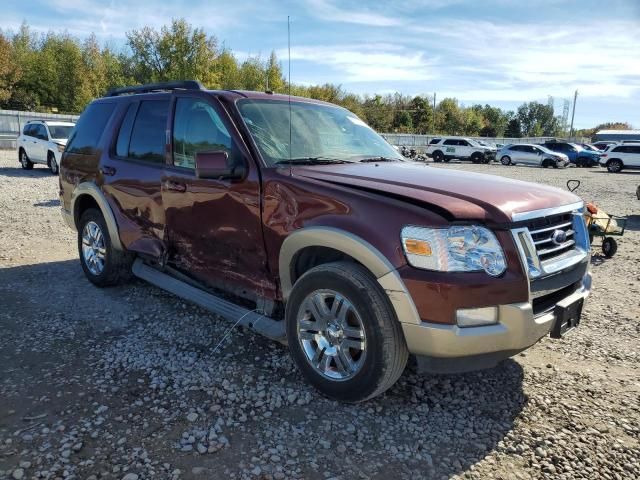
[401, 225, 507, 277]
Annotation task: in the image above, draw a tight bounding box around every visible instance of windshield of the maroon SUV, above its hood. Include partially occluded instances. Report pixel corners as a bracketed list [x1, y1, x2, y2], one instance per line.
[238, 99, 402, 166]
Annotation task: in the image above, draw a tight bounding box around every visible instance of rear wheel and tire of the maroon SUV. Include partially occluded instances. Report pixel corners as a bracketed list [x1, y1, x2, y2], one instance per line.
[78, 208, 135, 287]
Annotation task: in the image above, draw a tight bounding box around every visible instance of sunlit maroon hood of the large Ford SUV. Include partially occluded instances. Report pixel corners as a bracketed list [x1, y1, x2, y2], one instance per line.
[293, 162, 581, 223]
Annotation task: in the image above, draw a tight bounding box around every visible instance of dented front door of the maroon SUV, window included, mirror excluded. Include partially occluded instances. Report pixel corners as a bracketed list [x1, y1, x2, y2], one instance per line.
[162, 92, 275, 299]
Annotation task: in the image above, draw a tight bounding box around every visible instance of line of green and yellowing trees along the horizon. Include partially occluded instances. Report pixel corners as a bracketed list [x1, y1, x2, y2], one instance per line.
[0, 19, 630, 137]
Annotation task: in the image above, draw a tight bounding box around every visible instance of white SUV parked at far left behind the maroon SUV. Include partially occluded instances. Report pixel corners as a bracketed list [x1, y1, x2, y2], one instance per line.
[18, 120, 75, 175]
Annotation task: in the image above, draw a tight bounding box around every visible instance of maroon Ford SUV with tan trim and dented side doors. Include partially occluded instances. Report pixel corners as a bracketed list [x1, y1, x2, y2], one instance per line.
[60, 81, 591, 402]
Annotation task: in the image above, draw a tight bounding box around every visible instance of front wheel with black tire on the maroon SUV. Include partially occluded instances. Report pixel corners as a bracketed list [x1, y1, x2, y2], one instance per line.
[286, 262, 409, 403]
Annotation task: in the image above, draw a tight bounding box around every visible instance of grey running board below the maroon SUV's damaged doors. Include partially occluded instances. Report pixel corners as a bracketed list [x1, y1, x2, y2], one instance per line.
[132, 258, 286, 342]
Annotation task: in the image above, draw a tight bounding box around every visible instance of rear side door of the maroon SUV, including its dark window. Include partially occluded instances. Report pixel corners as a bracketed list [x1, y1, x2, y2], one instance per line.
[100, 94, 170, 258]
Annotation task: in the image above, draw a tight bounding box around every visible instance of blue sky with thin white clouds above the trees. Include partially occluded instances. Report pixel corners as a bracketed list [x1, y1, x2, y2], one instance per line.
[5, 0, 640, 128]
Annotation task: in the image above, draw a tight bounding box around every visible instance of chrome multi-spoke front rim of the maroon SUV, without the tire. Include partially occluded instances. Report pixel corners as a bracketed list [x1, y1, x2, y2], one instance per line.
[297, 290, 367, 381]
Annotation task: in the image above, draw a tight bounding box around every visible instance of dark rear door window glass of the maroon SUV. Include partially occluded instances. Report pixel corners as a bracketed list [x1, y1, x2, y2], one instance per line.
[127, 100, 169, 163]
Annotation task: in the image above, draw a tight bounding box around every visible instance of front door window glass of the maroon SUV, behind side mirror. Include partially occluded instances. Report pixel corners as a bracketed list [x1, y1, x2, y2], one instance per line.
[173, 97, 239, 168]
